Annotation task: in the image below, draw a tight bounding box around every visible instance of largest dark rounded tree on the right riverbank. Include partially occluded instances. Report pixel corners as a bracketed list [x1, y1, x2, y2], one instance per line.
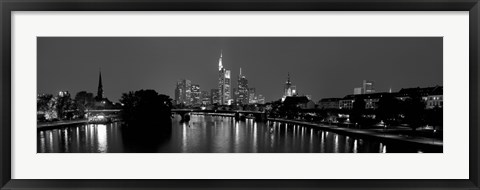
[403, 94, 425, 131]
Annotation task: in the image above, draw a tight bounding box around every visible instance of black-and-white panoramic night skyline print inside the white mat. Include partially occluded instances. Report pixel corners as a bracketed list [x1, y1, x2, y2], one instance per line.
[36, 37, 443, 154]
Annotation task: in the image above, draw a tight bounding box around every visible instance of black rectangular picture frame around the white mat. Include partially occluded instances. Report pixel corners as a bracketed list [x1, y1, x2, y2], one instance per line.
[0, 0, 480, 189]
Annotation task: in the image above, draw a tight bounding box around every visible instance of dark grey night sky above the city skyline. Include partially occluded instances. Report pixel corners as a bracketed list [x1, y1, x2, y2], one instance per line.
[37, 37, 443, 102]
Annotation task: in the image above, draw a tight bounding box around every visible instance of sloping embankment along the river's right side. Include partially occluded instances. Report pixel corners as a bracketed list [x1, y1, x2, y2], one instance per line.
[268, 118, 443, 152]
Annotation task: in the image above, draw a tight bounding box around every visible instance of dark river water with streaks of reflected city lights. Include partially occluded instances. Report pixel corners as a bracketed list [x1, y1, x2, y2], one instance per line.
[37, 115, 432, 153]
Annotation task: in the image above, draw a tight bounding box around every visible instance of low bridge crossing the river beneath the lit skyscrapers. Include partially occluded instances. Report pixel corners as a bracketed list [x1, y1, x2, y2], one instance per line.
[172, 109, 267, 122]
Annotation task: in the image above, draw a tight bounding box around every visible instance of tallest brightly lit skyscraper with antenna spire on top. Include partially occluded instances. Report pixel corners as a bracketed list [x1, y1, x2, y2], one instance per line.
[218, 52, 232, 105]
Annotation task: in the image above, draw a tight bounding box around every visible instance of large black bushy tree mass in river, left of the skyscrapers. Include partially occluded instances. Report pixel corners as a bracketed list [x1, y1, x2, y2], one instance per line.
[120, 90, 172, 128]
